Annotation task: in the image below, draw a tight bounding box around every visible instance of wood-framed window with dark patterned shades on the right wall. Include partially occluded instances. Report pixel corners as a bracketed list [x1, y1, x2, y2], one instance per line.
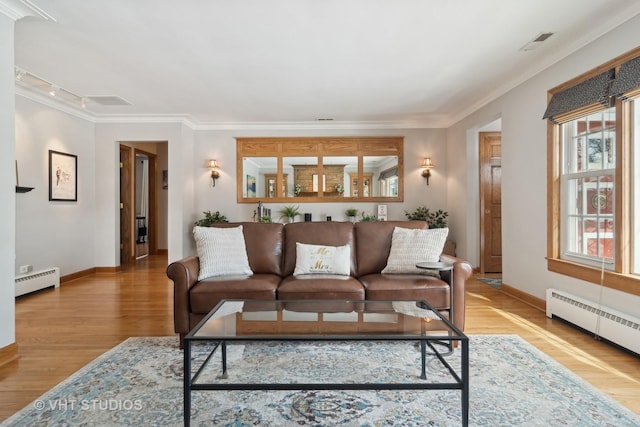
[544, 49, 640, 295]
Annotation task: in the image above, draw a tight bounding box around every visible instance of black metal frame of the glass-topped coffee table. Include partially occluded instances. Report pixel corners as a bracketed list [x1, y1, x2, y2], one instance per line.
[184, 301, 469, 427]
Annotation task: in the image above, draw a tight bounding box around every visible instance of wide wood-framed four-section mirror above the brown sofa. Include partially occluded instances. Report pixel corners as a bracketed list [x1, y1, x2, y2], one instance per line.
[236, 137, 404, 203]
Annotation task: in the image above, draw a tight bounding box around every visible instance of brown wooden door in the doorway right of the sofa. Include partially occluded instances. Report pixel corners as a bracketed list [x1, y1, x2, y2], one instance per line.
[480, 132, 502, 273]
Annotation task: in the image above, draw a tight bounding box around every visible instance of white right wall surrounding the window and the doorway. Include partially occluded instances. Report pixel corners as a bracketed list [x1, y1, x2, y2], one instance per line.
[447, 16, 640, 315]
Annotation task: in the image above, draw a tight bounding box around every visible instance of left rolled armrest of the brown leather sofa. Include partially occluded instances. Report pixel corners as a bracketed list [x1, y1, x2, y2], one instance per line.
[167, 256, 200, 334]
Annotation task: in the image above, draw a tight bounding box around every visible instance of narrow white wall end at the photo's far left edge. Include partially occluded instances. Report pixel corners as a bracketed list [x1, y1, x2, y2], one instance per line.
[0, 13, 16, 349]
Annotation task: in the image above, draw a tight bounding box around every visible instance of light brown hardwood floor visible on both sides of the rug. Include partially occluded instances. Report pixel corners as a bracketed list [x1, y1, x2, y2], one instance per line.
[0, 256, 640, 421]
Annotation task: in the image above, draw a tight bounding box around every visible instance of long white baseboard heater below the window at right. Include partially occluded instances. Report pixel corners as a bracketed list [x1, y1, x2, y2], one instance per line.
[547, 289, 640, 354]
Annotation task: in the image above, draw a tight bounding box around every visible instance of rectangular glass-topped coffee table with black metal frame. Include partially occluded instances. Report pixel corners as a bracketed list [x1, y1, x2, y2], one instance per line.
[184, 300, 469, 426]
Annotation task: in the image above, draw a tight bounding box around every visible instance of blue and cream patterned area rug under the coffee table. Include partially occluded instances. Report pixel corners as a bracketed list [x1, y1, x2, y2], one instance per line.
[2, 335, 640, 427]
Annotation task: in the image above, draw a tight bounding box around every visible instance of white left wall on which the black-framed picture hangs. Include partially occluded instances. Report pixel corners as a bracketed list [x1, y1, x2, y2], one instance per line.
[15, 96, 96, 275]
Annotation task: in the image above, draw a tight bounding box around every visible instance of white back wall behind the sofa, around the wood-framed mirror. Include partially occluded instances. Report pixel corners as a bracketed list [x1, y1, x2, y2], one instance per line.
[192, 129, 448, 251]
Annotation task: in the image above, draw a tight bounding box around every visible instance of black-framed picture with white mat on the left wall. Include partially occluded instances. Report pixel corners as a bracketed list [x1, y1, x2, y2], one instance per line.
[49, 150, 78, 202]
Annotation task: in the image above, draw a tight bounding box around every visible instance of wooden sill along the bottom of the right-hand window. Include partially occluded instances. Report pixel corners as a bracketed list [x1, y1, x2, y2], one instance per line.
[547, 258, 640, 296]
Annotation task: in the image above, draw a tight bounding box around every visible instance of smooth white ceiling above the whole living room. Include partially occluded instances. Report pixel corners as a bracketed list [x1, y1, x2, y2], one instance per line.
[7, 0, 640, 127]
